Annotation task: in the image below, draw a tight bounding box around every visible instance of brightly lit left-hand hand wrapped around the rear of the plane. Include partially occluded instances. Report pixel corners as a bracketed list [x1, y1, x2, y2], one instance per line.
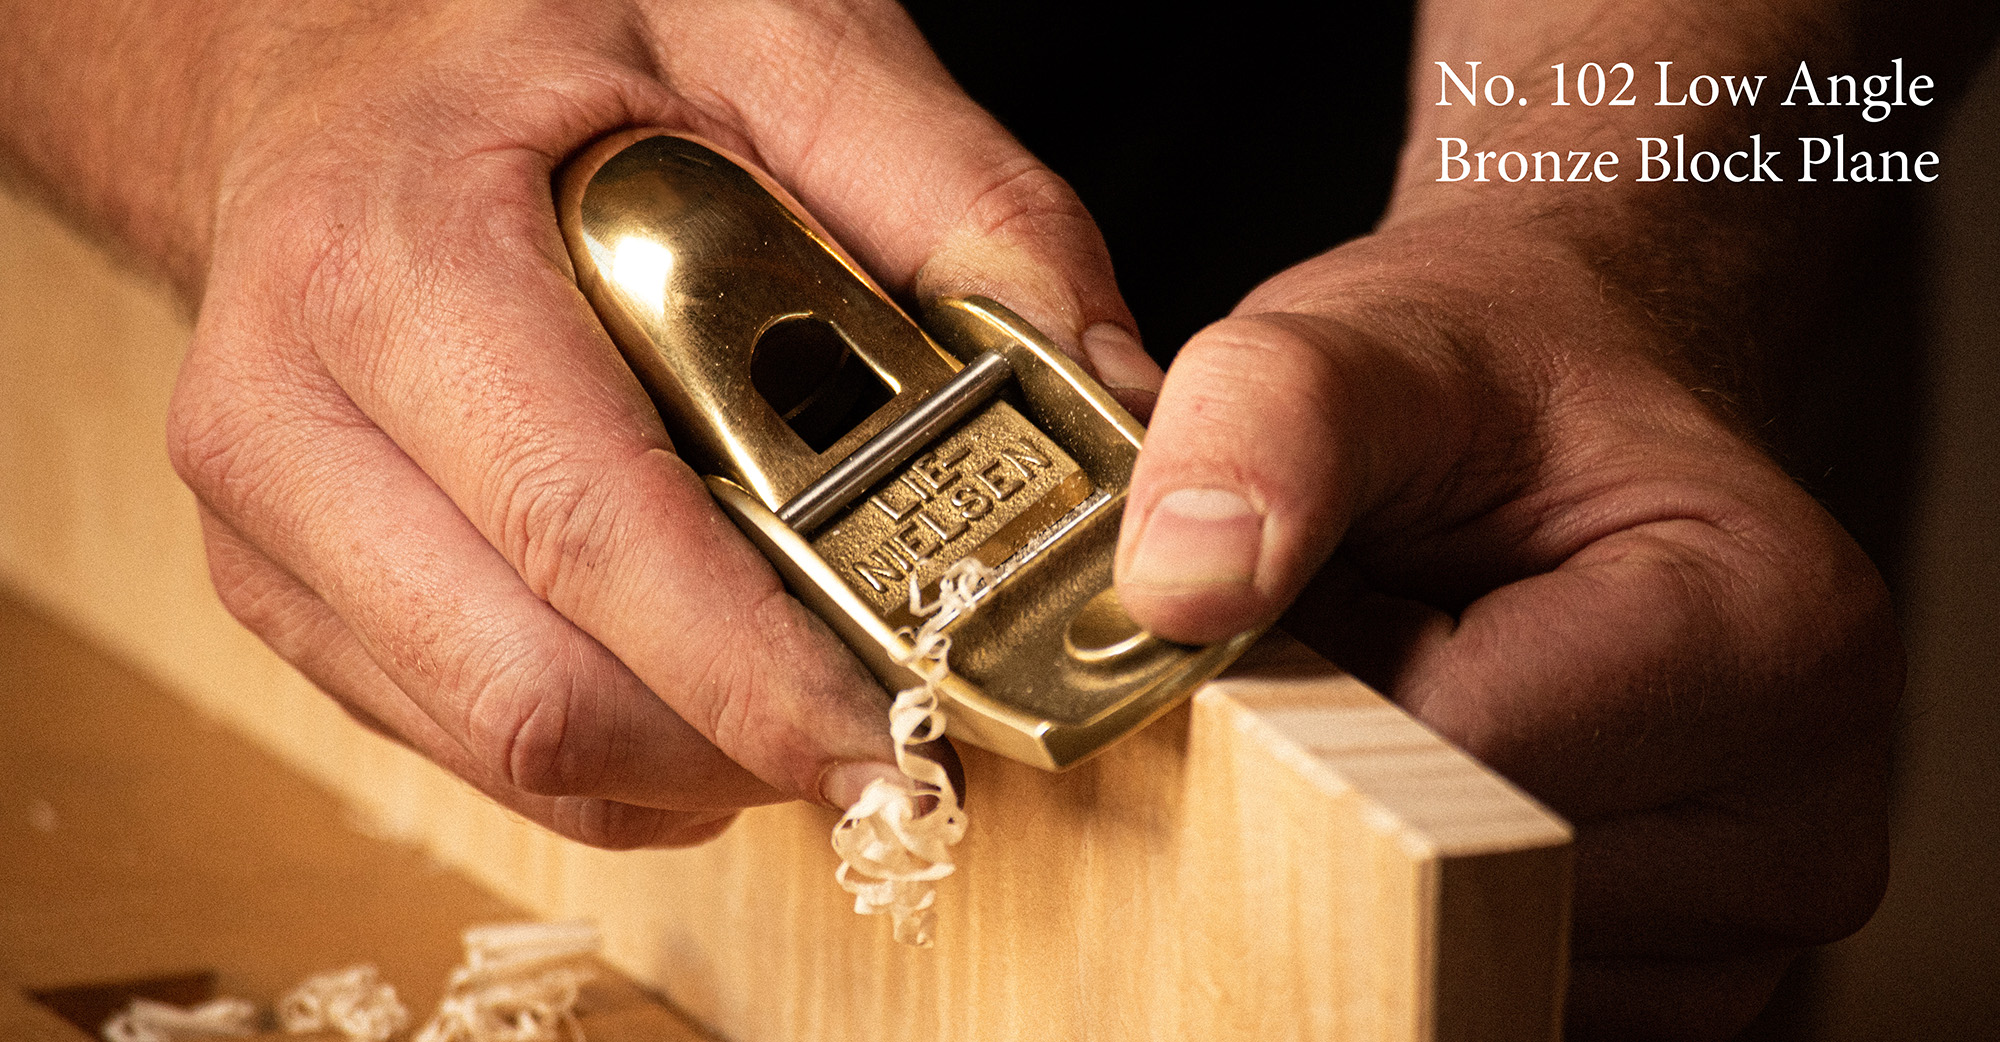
[168, 2, 1158, 846]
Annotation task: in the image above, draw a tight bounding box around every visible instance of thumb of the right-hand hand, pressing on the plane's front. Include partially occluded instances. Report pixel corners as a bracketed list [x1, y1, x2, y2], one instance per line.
[1116, 312, 1448, 642]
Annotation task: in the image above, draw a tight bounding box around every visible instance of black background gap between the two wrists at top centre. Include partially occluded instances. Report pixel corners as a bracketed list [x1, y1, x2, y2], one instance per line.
[910, 0, 1410, 360]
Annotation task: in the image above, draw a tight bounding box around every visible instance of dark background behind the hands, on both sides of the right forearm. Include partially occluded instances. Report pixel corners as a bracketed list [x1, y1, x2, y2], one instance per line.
[910, 0, 2000, 1042]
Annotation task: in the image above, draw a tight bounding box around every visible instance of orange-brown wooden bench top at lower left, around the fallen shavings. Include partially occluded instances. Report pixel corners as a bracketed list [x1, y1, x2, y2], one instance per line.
[0, 596, 720, 1042]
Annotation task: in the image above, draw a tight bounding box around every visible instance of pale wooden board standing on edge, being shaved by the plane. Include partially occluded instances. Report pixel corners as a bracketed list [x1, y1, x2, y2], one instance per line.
[0, 189, 1568, 1042]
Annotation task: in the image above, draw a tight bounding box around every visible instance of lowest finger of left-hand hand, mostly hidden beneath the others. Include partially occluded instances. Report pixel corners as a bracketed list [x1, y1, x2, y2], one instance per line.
[200, 500, 736, 850]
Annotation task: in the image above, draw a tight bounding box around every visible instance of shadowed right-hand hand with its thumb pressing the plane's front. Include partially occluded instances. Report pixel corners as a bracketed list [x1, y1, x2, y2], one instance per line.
[1118, 208, 1902, 1040]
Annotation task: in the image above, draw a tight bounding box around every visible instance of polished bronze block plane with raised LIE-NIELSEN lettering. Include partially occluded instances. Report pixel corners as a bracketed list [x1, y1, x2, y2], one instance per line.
[556, 130, 1254, 770]
